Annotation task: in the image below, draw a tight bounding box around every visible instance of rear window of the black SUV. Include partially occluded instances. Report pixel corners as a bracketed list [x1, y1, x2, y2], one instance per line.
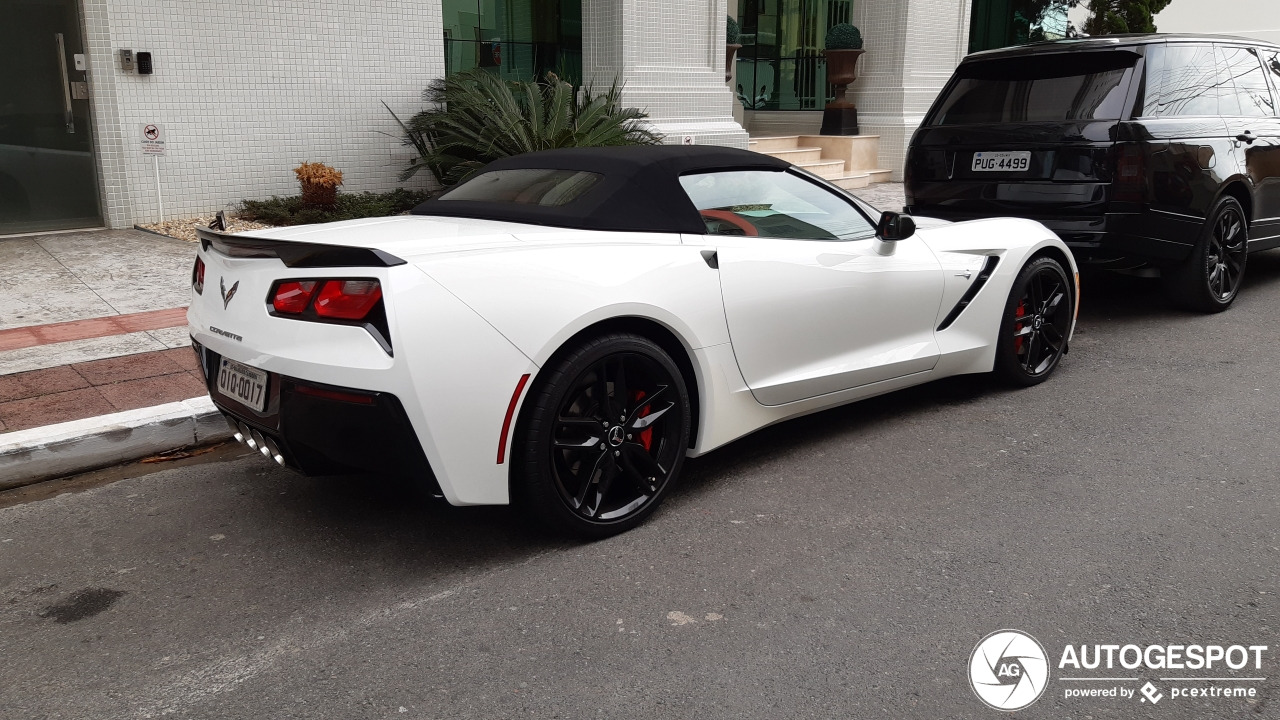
[929, 51, 1138, 126]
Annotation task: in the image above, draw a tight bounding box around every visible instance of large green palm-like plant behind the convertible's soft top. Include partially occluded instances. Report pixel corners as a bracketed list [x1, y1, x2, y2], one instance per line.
[384, 69, 662, 187]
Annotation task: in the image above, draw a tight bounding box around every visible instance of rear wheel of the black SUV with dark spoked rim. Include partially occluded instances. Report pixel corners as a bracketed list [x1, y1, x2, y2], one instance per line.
[1162, 195, 1249, 313]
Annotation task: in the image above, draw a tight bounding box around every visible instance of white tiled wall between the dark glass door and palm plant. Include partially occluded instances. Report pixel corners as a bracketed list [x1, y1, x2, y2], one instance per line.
[83, 0, 445, 227]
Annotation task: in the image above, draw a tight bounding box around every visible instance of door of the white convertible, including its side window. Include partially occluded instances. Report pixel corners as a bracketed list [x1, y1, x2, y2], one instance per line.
[681, 170, 943, 405]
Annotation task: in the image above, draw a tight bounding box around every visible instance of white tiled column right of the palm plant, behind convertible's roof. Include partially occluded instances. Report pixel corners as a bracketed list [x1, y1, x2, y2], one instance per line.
[582, 0, 746, 147]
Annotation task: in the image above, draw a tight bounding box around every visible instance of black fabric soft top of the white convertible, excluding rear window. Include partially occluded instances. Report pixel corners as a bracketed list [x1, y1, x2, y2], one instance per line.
[413, 145, 791, 234]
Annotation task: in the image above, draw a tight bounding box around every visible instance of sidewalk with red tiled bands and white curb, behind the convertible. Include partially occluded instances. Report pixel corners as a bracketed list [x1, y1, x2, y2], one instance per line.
[0, 183, 902, 489]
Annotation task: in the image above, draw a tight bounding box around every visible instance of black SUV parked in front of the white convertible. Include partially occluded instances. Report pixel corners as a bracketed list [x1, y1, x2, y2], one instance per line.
[905, 35, 1280, 311]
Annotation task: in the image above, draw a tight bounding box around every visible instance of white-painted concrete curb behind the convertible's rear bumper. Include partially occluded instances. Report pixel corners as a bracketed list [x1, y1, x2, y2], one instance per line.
[0, 396, 232, 491]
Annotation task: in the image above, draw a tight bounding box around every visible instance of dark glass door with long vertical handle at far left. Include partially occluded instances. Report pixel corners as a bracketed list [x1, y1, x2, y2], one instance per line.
[0, 0, 102, 234]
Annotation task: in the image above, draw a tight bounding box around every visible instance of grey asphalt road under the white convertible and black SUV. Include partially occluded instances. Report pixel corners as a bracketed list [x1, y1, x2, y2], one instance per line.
[0, 251, 1280, 720]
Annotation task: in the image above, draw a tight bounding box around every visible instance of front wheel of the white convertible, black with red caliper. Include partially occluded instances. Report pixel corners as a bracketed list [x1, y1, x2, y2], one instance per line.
[995, 258, 1075, 387]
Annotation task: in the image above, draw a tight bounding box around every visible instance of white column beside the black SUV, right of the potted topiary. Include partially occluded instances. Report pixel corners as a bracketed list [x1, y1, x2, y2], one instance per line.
[849, 0, 972, 181]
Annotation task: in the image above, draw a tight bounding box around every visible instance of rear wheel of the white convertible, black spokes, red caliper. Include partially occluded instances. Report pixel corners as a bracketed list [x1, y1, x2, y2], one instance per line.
[512, 333, 691, 539]
